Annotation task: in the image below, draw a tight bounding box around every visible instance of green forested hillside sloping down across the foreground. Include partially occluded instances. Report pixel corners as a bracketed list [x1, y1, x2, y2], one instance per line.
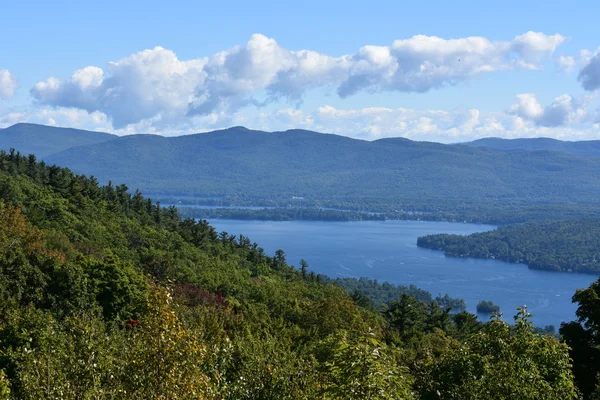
[0, 148, 600, 400]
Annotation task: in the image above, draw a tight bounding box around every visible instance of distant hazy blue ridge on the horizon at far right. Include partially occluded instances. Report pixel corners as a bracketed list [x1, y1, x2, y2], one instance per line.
[463, 138, 600, 157]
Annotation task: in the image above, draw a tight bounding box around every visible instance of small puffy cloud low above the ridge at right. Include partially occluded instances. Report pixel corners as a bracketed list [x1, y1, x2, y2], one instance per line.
[507, 93, 593, 127]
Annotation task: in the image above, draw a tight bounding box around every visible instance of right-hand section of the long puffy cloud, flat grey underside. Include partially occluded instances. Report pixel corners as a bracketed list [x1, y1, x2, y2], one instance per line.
[338, 32, 565, 97]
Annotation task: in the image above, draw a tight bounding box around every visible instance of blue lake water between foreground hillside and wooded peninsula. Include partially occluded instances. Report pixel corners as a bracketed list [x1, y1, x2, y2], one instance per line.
[210, 220, 597, 329]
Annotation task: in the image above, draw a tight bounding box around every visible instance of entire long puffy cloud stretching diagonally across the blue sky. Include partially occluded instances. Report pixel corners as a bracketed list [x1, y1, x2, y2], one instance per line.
[31, 32, 564, 129]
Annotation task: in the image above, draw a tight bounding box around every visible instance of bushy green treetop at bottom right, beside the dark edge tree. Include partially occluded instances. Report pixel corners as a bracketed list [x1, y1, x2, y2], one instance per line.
[417, 309, 577, 400]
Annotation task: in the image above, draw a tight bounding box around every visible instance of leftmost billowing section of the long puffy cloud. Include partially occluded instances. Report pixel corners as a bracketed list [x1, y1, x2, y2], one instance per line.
[31, 47, 206, 128]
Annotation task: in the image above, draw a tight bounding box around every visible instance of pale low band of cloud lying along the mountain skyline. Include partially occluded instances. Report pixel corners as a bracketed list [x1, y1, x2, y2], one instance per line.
[0, 100, 600, 143]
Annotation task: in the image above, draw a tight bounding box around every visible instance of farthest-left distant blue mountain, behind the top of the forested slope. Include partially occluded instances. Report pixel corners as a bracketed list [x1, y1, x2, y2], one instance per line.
[0, 124, 117, 158]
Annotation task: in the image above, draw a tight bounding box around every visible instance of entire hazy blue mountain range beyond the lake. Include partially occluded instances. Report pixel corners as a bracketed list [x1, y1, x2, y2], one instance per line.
[0, 124, 600, 214]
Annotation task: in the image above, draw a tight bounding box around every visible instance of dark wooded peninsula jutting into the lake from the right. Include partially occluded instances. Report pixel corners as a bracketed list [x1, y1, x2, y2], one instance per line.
[417, 218, 600, 273]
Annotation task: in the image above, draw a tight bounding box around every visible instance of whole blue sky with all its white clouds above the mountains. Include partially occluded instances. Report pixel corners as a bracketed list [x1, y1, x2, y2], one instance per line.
[0, 0, 600, 142]
